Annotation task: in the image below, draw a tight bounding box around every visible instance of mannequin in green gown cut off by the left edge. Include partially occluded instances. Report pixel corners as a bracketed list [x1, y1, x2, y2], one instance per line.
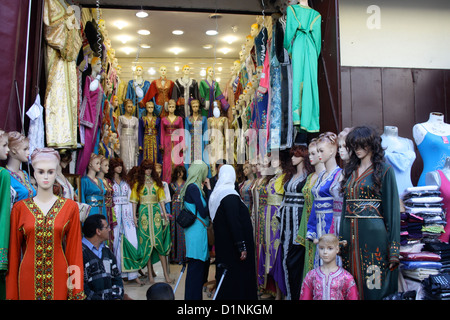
[0, 130, 12, 300]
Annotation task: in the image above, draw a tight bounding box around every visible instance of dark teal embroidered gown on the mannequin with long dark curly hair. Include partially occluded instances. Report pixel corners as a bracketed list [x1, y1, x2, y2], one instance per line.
[340, 164, 400, 300]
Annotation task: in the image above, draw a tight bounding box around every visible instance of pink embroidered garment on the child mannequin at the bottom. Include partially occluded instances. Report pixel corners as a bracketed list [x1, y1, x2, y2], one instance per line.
[300, 267, 359, 300]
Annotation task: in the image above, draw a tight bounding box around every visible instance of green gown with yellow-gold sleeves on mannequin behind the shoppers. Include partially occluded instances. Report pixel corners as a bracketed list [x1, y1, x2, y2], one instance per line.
[122, 183, 170, 272]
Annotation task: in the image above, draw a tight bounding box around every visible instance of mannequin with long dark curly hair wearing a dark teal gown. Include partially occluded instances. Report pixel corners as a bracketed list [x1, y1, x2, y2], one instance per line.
[339, 126, 400, 300]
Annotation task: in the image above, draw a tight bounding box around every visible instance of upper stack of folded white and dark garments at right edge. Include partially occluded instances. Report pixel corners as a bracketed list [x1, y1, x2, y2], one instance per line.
[402, 186, 446, 243]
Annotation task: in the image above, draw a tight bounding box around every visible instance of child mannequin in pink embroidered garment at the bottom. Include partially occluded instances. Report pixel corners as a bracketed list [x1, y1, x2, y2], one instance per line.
[300, 233, 359, 300]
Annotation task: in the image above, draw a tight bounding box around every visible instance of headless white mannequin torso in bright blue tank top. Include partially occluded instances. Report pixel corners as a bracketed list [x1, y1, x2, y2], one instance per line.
[413, 112, 450, 187]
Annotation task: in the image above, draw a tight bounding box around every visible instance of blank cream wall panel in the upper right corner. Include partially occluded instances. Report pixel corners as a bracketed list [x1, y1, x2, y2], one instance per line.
[339, 0, 450, 69]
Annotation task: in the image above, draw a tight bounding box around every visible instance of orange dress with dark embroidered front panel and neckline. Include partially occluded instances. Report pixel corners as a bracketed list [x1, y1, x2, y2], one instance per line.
[6, 197, 85, 300]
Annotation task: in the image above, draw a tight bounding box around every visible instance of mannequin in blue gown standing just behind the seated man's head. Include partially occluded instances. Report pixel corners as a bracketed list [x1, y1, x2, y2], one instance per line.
[78, 153, 107, 218]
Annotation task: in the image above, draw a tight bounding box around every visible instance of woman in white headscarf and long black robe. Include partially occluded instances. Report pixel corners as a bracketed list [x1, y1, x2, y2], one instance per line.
[208, 165, 258, 300]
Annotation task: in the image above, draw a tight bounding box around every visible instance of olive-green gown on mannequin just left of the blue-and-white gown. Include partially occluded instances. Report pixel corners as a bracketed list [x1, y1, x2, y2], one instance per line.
[295, 173, 317, 280]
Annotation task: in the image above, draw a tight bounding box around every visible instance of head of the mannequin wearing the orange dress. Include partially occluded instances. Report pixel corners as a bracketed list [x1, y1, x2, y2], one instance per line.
[31, 148, 60, 191]
